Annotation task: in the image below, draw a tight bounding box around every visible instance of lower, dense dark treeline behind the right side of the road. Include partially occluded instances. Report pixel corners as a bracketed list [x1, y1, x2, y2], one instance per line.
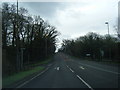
[59, 32, 120, 61]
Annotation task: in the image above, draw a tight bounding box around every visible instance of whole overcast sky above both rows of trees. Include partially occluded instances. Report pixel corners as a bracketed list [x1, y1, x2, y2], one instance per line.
[7, 0, 119, 49]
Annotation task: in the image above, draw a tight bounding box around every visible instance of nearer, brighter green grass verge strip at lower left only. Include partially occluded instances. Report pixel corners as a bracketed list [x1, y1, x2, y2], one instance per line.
[2, 66, 44, 87]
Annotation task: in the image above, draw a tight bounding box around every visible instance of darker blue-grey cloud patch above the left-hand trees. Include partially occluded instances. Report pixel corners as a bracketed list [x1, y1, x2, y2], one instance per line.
[20, 2, 62, 18]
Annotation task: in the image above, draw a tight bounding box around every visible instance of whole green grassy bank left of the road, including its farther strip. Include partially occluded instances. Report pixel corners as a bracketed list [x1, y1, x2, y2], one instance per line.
[2, 59, 52, 87]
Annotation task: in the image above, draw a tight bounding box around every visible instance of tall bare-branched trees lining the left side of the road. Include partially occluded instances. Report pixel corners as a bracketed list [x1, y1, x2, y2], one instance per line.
[2, 3, 59, 74]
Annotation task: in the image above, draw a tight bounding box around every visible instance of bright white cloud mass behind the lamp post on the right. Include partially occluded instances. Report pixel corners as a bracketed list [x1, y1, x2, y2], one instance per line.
[50, 1, 117, 36]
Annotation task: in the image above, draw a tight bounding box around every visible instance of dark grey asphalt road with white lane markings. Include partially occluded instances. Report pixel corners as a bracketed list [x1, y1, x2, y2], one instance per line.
[17, 53, 120, 90]
